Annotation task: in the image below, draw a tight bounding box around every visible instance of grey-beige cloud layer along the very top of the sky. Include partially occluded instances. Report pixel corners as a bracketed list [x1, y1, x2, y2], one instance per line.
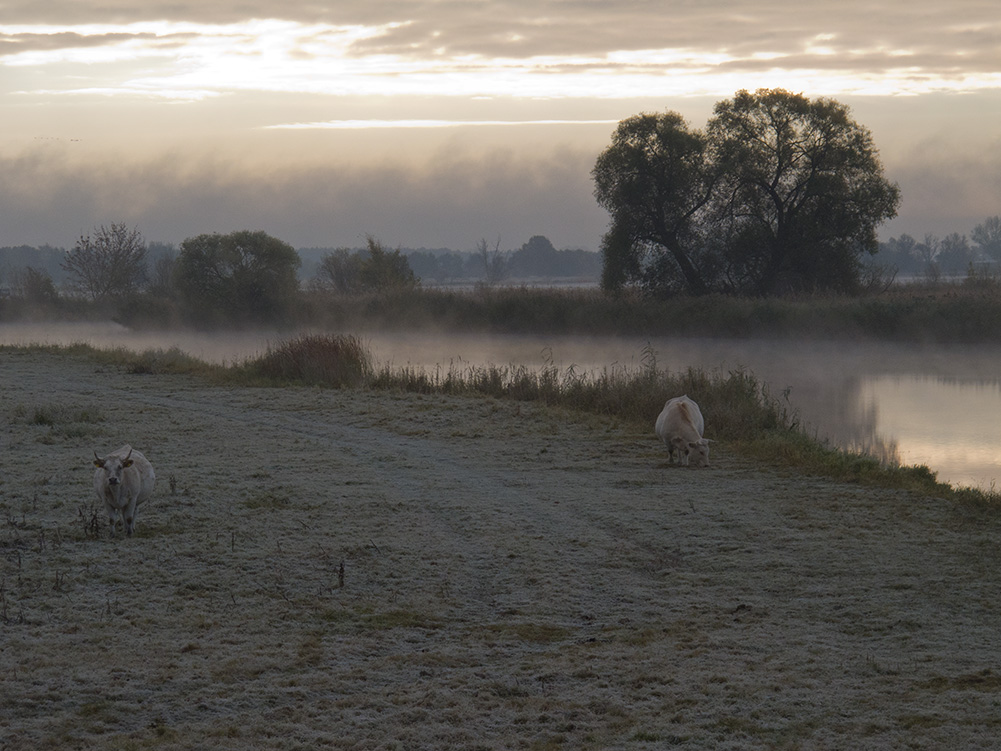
[4, 0, 1001, 64]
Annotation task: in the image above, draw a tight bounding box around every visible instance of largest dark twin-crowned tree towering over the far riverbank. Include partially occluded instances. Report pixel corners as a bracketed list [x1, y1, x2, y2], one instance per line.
[592, 89, 899, 294]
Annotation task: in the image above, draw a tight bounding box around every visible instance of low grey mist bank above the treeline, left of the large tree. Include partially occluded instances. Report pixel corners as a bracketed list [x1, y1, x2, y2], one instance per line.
[0, 148, 607, 249]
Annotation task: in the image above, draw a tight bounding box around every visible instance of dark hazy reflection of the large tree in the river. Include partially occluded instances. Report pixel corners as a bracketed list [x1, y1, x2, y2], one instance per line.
[772, 376, 900, 466]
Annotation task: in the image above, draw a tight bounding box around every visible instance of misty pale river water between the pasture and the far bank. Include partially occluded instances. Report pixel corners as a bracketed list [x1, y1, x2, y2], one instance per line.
[0, 322, 1001, 489]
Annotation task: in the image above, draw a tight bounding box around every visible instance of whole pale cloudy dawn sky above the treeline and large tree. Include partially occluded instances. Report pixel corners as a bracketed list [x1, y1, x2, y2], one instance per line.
[0, 0, 1001, 250]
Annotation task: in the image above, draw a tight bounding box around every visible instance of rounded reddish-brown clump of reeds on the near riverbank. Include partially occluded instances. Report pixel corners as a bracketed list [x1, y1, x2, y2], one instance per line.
[239, 334, 372, 389]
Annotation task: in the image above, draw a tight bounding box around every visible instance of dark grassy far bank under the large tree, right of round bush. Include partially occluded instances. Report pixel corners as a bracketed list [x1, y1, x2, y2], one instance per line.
[298, 277, 1001, 343]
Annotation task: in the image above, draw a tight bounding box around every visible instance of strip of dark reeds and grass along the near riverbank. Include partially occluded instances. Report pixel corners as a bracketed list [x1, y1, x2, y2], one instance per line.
[11, 334, 1001, 506]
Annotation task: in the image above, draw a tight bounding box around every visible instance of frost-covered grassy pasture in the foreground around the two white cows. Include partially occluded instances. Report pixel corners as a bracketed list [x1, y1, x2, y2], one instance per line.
[0, 352, 1001, 751]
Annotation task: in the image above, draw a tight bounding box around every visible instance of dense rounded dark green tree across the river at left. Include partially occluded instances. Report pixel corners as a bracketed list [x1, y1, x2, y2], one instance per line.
[174, 230, 301, 322]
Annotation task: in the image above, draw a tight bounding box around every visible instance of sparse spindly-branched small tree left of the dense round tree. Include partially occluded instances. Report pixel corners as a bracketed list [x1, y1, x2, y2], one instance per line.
[62, 223, 146, 300]
